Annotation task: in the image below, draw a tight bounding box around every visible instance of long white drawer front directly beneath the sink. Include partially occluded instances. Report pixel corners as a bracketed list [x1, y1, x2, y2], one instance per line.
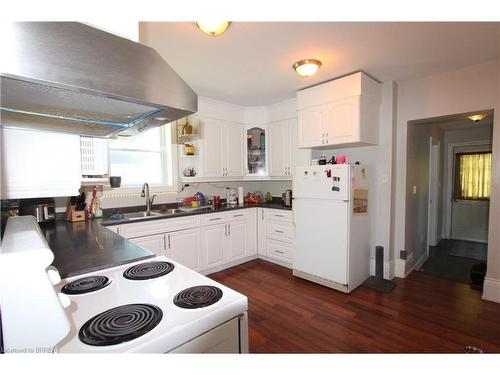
[120, 215, 200, 238]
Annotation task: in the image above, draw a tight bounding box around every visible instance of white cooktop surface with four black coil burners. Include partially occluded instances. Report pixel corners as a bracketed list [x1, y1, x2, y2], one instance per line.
[56, 256, 247, 353]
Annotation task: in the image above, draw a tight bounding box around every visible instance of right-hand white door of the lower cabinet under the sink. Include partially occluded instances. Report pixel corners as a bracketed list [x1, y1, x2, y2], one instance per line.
[166, 229, 201, 271]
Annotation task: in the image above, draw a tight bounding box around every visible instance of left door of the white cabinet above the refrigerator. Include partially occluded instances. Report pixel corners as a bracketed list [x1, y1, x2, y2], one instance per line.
[298, 106, 325, 148]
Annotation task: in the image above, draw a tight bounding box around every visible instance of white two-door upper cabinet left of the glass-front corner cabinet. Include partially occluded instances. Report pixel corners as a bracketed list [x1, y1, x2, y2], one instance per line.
[200, 118, 243, 177]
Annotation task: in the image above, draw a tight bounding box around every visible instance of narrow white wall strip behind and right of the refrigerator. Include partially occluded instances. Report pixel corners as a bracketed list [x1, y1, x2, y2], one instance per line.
[312, 82, 396, 278]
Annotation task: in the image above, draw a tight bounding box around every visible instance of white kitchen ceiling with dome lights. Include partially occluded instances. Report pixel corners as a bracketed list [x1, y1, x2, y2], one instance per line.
[140, 22, 500, 106]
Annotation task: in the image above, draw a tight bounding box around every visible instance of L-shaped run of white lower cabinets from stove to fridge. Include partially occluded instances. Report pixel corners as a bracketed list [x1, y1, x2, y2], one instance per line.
[112, 208, 288, 273]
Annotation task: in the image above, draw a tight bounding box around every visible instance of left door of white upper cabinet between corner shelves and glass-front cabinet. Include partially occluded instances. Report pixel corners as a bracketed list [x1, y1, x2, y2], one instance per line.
[200, 119, 224, 177]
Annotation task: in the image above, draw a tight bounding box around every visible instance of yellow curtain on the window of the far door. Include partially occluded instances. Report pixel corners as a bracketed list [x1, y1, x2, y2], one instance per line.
[455, 152, 491, 200]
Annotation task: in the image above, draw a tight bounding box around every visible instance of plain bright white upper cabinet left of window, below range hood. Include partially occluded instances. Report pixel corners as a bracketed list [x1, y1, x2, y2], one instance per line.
[1, 129, 82, 199]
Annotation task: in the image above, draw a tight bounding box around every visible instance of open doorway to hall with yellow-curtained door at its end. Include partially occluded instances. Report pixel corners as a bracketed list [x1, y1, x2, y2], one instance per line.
[406, 110, 493, 285]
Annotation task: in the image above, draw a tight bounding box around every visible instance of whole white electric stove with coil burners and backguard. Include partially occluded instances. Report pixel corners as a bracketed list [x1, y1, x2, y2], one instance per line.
[0, 217, 248, 353]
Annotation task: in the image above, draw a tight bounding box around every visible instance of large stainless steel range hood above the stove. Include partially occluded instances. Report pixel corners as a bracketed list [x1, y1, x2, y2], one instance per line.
[0, 22, 198, 138]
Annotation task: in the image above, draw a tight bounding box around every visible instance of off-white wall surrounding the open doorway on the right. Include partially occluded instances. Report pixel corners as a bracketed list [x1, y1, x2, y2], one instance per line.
[393, 60, 500, 280]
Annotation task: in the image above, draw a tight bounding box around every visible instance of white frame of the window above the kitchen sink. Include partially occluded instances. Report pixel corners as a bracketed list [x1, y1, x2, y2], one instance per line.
[106, 121, 178, 196]
